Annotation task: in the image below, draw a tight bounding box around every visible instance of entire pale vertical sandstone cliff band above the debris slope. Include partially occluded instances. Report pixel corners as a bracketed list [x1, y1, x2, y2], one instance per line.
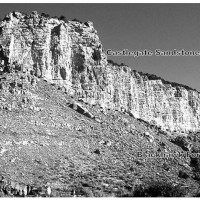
[0, 12, 200, 132]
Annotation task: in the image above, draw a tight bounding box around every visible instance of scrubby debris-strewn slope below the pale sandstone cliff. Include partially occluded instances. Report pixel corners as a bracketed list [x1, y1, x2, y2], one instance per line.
[0, 72, 199, 196]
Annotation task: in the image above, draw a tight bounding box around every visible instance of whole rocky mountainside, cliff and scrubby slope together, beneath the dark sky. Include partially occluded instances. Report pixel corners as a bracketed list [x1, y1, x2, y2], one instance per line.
[0, 5, 200, 197]
